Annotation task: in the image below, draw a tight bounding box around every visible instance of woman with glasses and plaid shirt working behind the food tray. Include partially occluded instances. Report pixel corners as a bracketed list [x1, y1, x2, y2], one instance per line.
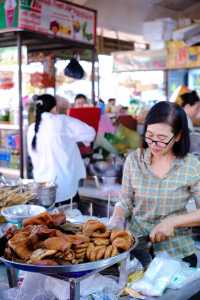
[110, 101, 200, 268]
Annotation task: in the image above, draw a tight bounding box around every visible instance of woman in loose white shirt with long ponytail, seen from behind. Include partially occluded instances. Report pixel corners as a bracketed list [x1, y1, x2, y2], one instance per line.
[28, 94, 95, 203]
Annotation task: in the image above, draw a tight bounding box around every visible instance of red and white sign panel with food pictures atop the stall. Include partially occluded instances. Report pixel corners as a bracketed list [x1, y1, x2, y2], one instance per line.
[18, 0, 96, 45]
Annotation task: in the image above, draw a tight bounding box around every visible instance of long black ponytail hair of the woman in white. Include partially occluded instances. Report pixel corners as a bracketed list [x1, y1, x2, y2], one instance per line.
[32, 94, 56, 150]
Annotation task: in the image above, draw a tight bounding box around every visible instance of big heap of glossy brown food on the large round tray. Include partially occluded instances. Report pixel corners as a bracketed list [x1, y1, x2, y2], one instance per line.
[4, 212, 134, 265]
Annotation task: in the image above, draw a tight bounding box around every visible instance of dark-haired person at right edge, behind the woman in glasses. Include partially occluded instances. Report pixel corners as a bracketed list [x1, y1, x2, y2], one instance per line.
[180, 91, 200, 132]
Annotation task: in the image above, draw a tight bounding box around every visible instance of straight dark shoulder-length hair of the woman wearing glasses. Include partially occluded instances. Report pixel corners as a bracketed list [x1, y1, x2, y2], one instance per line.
[142, 101, 190, 157]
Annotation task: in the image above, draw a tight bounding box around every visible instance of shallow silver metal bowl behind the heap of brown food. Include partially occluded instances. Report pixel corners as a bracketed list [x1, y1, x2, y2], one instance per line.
[1, 204, 46, 223]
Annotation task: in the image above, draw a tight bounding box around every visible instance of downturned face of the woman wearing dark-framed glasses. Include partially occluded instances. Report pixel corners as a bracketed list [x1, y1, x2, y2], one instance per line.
[145, 123, 179, 156]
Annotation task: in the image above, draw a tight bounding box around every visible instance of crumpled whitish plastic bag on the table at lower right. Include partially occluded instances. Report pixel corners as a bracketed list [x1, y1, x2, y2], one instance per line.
[130, 252, 184, 296]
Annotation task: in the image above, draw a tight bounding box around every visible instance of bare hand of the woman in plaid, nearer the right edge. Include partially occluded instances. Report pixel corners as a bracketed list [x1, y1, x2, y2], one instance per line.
[150, 217, 175, 243]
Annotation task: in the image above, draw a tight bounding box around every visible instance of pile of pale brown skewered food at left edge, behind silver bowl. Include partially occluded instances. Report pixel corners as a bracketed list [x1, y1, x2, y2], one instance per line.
[0, 187, 34, 209]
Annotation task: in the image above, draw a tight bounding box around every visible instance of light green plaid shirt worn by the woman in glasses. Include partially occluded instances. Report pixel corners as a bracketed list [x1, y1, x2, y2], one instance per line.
[117, 149, 200, 258]
